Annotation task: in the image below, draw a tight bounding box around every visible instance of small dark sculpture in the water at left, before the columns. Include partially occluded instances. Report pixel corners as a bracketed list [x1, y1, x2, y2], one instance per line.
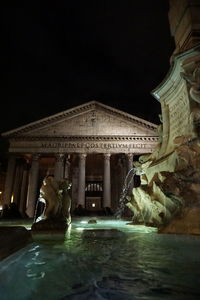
[32, 176, 71, 230]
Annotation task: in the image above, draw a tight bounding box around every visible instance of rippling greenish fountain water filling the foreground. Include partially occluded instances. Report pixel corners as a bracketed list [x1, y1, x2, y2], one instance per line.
[0, 219, 200, 300]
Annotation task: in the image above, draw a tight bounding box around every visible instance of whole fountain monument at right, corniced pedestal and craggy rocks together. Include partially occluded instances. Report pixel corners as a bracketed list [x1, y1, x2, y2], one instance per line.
[127, 47, 200, 234]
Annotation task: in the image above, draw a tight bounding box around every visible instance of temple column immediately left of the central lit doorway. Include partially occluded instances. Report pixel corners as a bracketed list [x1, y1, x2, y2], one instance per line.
[77, 153, 87, 208]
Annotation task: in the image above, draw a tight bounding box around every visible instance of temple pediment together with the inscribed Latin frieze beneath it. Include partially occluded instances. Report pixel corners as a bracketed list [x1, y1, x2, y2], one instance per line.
[3, 101, 158, 154]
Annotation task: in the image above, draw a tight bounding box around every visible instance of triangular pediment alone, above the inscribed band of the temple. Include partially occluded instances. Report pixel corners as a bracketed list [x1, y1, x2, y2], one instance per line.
[3, 101, 157, 138]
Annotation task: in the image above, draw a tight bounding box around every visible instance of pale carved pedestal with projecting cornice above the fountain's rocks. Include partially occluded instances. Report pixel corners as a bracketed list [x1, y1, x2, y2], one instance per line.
[152, 44, 200, 159]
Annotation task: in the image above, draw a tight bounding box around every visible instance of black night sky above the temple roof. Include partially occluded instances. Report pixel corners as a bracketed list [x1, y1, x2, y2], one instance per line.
[0, 0, 174, 132]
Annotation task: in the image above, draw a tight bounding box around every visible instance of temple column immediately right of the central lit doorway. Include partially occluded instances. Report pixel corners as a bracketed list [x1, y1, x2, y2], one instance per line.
[103, 153, 111, 207]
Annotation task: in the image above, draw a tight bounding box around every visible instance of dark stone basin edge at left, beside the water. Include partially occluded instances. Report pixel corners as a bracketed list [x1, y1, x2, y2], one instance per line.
[0, 226, 32, 260]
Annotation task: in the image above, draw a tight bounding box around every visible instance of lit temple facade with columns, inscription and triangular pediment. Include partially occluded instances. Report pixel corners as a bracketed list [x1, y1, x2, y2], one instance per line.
[2, 101, 158, 218]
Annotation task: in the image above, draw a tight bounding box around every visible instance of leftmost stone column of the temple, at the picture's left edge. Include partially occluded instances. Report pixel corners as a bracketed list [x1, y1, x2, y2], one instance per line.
[3, 155, 16, 205]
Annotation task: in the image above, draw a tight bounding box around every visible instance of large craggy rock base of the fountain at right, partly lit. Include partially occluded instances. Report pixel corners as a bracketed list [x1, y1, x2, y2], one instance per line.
[126, 137, 200, 234]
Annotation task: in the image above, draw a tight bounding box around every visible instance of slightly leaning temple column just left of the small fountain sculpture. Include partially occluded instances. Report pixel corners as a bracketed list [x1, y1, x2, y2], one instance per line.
[26, 154, 40, 218]
